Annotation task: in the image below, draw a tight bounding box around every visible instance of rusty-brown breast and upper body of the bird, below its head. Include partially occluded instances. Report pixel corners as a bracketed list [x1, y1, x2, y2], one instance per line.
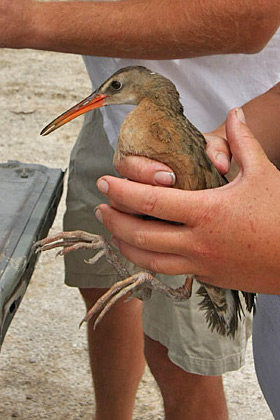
[114, 100, 224, 190]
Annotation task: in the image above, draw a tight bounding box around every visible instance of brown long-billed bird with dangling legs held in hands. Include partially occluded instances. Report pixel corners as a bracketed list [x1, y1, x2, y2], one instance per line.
[36, 66, 254, 337]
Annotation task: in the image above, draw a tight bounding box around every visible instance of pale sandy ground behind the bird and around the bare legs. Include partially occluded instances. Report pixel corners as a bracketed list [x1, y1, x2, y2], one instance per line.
[0, 50, 273, 420]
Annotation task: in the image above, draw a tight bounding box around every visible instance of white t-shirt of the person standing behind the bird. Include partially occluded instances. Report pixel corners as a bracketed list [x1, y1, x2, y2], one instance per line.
[84, 29, 280, 147]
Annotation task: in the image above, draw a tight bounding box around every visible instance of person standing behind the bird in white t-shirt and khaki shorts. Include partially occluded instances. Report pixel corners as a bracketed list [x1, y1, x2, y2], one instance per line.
[0, 0, 280, 420]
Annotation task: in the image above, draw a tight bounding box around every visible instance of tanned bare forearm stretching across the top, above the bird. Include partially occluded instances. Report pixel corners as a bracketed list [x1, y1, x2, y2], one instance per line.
[0, 0, 280, 59]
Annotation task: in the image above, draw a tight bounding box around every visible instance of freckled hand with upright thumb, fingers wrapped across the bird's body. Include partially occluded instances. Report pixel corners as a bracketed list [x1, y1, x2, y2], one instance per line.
[96, 109, 280, 293]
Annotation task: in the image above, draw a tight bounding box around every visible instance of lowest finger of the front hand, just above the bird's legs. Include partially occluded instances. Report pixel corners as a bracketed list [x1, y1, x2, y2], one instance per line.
[110, 238, 198, 275]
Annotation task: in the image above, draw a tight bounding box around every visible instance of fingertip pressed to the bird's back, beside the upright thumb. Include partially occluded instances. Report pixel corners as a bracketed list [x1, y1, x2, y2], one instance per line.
[204, 133, 231, 174]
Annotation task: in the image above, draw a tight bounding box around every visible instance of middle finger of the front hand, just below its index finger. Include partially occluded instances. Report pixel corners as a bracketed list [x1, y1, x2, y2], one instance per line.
[95, 204, 190, 254]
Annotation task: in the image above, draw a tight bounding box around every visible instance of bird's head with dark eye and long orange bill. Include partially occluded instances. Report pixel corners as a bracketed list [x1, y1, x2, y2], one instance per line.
[41, 66, 179, 135]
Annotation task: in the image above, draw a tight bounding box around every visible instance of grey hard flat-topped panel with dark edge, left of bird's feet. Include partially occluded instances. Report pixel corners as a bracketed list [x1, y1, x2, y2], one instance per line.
[0, 161, 64, 348]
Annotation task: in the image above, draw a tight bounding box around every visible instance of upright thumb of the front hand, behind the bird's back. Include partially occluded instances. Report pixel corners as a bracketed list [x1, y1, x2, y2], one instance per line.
[226, 108, 266, 171]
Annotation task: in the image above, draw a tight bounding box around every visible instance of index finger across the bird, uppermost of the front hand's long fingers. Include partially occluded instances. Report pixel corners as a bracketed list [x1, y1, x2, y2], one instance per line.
[97, 175, 212, 226]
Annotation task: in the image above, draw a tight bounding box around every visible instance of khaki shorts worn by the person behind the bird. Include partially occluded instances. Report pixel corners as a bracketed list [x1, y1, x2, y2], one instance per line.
[64, 111, 251, 375]
